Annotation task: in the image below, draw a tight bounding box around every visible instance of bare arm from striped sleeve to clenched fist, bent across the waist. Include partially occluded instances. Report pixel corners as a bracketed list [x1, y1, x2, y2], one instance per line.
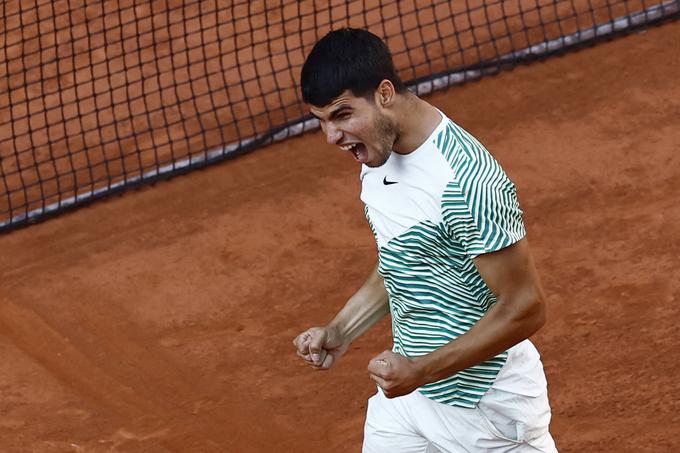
[369, 238, 545, 397]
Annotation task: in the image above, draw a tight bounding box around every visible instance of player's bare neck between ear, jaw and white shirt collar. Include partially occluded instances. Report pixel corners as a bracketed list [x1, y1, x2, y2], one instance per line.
[392, 93, 442, 154]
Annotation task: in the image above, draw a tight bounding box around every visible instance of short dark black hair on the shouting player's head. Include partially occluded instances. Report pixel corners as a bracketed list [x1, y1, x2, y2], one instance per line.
[300, 28, 406, 107]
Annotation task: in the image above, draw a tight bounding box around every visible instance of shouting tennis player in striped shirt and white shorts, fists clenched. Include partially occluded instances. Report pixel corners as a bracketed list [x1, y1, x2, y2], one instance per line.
[294, 29, 557, 453]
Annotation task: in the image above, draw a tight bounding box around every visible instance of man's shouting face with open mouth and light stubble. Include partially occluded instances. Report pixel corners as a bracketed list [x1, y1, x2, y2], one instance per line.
[310, 91, 398, 167]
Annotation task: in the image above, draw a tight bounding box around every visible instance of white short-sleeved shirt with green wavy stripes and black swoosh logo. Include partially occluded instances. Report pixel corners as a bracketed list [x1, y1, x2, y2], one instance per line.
[361, 112, 542, 407]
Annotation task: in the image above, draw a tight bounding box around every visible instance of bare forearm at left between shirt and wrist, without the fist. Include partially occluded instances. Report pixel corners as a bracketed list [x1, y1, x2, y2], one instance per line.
[329, 267, 389, 343]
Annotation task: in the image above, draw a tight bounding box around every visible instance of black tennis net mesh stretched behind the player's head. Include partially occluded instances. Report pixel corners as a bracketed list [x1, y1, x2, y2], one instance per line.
[0, 0, 680, 231]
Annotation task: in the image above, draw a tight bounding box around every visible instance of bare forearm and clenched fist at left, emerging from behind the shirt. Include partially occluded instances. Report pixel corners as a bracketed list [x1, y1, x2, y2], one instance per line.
[293, 266, 389, 370]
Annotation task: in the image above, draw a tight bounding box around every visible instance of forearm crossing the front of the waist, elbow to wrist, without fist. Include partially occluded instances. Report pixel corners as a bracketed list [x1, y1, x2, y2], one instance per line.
[415, 295, 545, 383]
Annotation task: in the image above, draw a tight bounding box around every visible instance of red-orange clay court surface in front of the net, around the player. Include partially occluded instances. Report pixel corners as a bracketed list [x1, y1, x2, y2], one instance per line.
[0, 0, 680, 453]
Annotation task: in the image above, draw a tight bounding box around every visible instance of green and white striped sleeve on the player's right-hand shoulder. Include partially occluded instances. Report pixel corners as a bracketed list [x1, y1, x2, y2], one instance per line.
[442, 153, 526, 258]
